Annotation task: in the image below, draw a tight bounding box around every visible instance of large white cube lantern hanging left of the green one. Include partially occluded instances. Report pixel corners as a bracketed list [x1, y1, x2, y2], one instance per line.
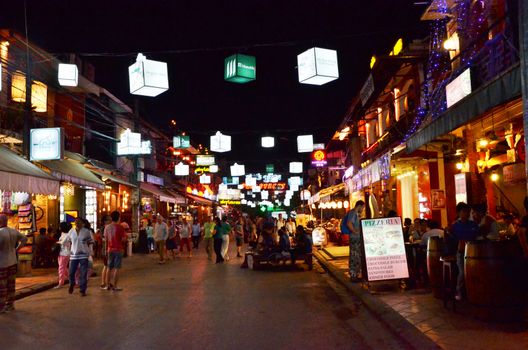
[128, 53, 169, 97]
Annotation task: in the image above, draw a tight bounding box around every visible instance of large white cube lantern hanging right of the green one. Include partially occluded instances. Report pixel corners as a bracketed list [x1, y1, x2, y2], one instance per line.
[297, 47, 339, 85]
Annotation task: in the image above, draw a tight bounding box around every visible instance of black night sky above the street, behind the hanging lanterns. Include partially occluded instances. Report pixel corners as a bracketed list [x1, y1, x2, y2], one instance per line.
[0, 0, 427, 171]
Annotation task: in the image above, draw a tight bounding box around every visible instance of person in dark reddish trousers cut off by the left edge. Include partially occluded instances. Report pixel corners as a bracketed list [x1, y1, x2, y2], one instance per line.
[0, 214, 27, 314]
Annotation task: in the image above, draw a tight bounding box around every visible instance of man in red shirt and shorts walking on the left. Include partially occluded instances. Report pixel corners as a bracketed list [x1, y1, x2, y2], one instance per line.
[104, 211, 127, 292]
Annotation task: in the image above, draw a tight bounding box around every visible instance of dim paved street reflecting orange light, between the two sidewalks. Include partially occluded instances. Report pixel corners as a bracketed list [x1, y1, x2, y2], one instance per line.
[0, 243, 405, 350]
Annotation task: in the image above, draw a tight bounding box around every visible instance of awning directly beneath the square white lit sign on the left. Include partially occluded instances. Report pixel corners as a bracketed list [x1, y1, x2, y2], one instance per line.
[39, 159, 105, 190]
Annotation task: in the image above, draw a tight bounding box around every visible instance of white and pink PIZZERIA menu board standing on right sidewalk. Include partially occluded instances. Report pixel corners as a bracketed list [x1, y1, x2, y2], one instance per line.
[361, 217, 409, 281]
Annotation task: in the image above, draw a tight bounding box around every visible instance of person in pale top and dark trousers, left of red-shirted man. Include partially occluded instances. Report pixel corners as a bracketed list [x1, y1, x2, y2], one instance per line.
[66, 218, 93, 297]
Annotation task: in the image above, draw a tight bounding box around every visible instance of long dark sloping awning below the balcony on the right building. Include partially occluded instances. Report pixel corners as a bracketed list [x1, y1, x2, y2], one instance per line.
[407, 65, 521, 153]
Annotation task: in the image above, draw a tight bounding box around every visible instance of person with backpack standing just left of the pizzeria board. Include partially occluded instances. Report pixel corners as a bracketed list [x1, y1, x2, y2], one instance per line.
[341, 200, 365, 282]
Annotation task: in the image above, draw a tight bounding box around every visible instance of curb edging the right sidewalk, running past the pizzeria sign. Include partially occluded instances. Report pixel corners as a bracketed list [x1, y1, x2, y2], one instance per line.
[313, 251, 441, 349]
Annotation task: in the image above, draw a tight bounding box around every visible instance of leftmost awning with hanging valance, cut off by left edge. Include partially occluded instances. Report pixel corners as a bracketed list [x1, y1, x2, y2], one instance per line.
[0, 146, 60, 196]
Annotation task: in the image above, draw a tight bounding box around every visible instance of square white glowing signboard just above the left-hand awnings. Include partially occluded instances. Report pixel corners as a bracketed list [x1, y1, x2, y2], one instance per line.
[29, 128, 64, 161]
